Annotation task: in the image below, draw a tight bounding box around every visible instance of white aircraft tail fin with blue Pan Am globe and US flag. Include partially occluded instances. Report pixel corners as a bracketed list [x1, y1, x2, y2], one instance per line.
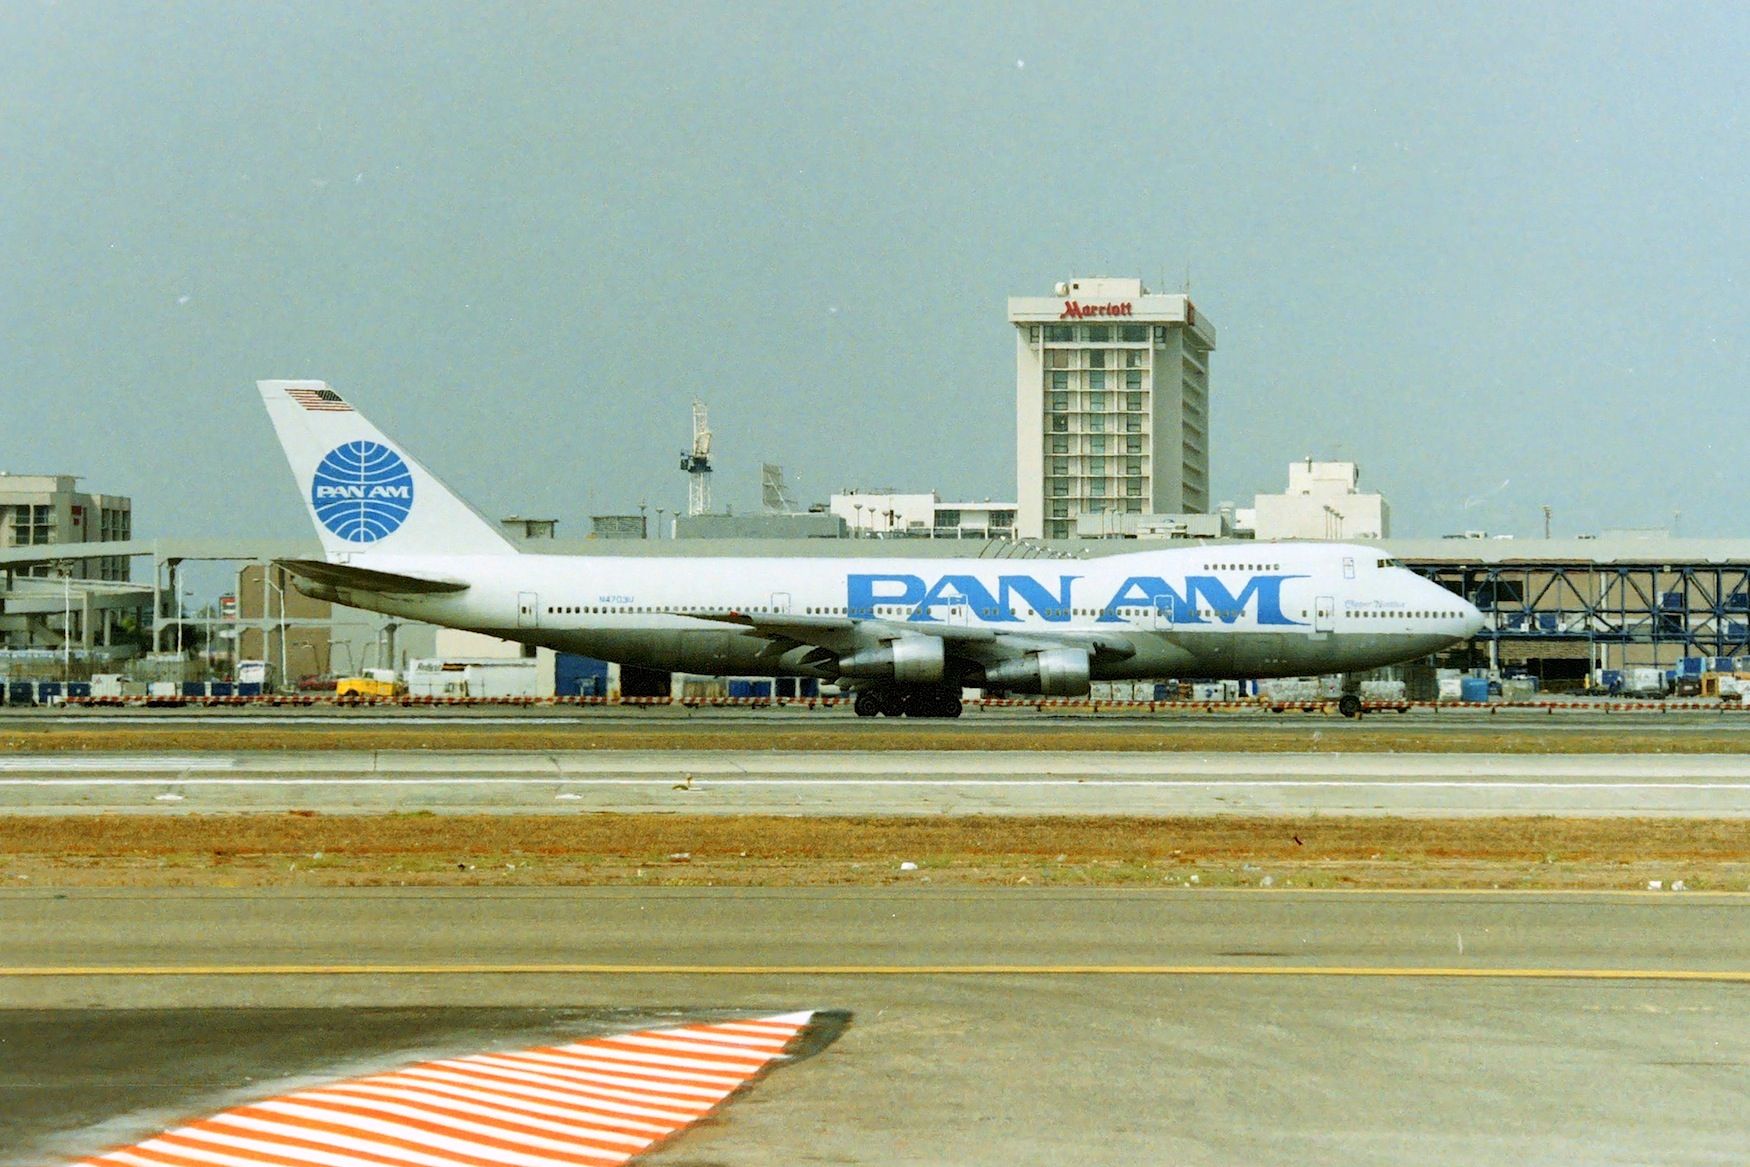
[256, 381, 516, 560]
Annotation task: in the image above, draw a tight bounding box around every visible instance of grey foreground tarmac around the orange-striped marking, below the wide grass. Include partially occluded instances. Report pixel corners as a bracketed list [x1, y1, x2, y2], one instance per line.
[0, 889, 1750, 1167]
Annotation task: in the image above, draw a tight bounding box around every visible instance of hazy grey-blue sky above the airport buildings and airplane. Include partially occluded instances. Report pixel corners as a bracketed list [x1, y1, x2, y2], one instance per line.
[0, 0, 1750, 535]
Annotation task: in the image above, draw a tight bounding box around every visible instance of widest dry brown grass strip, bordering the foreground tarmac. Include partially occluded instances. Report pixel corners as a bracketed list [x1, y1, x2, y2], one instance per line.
[0, 814, 1750, 891]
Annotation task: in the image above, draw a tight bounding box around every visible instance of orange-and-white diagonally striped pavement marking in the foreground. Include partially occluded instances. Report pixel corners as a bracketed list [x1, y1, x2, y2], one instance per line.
[61, 1011, 816, 1167]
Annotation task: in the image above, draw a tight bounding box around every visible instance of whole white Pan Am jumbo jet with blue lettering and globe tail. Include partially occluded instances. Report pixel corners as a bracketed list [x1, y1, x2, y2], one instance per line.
[257, 381, 1482, 717]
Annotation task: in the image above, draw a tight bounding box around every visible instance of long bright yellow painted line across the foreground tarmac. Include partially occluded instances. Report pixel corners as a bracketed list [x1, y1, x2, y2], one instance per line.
[0, 964, 1750, 983]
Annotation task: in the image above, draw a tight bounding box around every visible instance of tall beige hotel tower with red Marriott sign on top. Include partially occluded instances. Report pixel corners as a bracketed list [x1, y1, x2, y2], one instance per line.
[1008, 278, 1215, 539]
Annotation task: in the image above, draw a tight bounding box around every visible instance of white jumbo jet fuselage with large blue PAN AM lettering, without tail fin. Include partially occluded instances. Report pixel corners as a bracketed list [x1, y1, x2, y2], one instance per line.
[311, 542, 1482, 679]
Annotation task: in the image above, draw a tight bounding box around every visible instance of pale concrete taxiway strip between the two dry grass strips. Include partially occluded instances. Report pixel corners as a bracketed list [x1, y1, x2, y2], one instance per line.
[0, 751, 1750, 817]
